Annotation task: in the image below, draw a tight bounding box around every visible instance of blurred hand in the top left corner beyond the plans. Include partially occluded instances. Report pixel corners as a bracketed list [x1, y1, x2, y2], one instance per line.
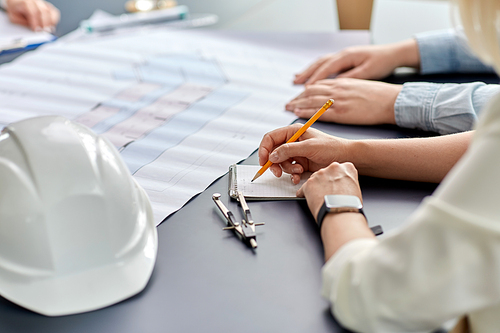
[6, 0, 61, 31]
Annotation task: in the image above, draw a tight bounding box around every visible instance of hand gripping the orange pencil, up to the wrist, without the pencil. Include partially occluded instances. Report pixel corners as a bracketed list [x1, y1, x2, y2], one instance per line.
[259, 124, 349, 184]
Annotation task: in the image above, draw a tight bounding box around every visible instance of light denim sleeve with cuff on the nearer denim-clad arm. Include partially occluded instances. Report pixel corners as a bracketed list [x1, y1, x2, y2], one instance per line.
[394, 82, 500, 134]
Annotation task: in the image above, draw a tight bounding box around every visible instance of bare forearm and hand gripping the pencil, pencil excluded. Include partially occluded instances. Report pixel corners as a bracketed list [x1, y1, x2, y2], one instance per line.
[258, 124, 472, 183]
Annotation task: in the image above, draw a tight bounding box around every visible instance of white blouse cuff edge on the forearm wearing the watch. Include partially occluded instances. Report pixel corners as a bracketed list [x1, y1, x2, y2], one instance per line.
[321, 238, 379, 303]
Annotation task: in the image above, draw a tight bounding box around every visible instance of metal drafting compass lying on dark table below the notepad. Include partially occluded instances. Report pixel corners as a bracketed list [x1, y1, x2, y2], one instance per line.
[212, 191, 264, 249]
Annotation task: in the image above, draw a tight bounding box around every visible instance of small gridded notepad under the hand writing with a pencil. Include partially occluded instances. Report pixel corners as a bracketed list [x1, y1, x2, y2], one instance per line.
[229, 165, 311, 200]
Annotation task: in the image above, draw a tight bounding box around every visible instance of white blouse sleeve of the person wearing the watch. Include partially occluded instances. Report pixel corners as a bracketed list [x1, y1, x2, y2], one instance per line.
[323, 97, 500, 333]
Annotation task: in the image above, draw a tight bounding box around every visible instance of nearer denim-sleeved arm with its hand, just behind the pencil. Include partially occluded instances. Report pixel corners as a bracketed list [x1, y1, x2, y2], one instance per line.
[286, 78, 500, 134]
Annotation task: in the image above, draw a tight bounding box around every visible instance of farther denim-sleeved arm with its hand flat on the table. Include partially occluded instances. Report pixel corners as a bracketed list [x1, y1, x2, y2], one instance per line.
[294, 30, 494, 85]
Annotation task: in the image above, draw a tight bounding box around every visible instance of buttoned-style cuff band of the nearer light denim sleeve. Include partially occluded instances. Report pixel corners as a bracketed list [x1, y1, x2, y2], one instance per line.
[394, 82, 442, 132]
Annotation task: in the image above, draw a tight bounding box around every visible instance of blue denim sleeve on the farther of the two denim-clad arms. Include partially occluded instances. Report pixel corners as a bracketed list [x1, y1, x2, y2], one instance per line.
[414, 30, 494, 74]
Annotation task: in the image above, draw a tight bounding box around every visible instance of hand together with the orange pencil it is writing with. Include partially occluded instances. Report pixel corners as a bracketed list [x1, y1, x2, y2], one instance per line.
[254, 100, 346, 183]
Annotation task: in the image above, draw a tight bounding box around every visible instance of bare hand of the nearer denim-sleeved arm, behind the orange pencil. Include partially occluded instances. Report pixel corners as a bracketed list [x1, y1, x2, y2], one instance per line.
[285, 78, 402, 125]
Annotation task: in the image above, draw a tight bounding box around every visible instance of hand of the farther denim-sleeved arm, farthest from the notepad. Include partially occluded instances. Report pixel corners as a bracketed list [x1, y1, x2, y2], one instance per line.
[293, 39, 420, 84]
